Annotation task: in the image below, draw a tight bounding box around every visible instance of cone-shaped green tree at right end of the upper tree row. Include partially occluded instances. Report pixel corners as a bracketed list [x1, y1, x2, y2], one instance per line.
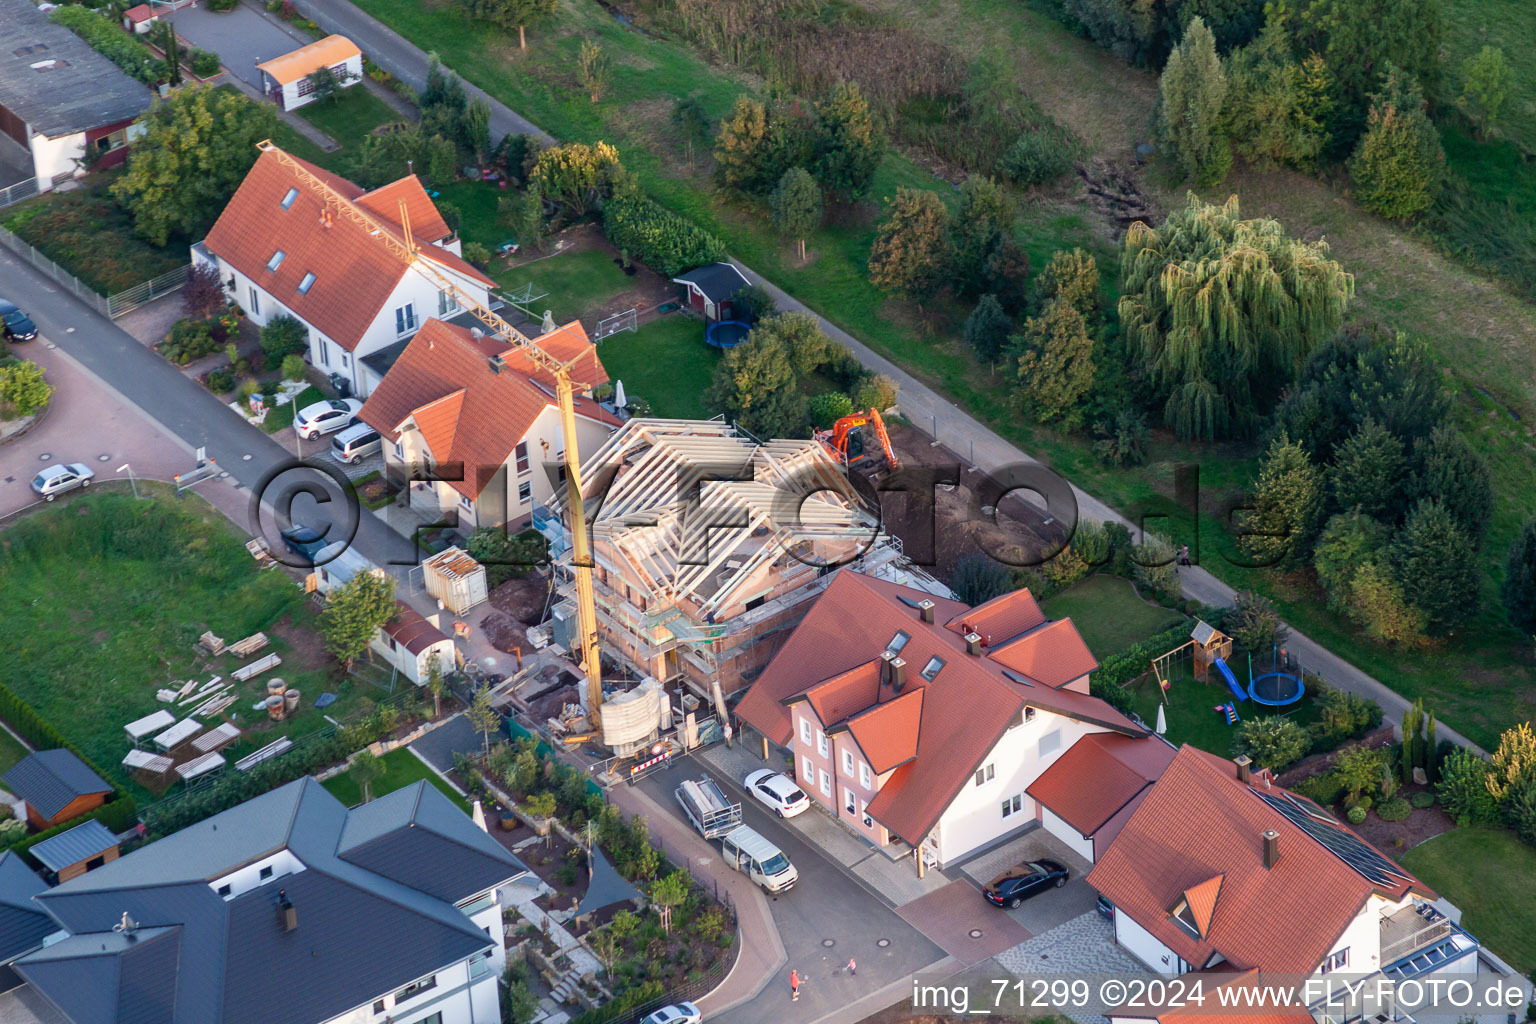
[1349, 71, 1445, 221]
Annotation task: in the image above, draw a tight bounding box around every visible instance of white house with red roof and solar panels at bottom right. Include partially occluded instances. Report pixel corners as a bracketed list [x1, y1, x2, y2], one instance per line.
[1087, 746, 1478, 1021]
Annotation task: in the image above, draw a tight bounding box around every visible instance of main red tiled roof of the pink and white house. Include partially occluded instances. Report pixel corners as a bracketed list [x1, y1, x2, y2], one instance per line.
[737, 570, 1146, 843]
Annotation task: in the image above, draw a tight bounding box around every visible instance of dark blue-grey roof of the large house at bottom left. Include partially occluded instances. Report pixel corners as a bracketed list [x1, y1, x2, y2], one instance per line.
[17, 778, 524, 1024]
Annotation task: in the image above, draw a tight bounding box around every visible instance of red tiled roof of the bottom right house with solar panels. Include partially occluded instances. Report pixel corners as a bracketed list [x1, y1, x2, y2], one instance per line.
[1087, 746, 1433, 973]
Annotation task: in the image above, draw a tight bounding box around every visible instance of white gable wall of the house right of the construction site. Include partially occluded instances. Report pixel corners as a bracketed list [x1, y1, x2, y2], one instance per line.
[926, 709, 1107, 866]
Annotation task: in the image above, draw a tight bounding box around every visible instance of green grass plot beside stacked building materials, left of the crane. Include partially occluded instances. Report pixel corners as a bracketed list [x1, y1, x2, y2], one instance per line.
[0, 491, 387, 794]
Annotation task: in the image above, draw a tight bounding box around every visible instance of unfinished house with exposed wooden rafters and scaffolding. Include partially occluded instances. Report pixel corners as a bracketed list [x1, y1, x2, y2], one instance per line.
[535, 419, 949, 721]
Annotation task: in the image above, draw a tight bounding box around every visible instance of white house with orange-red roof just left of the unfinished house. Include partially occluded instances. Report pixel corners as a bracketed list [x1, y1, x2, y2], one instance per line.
[359, 319, 619, 534]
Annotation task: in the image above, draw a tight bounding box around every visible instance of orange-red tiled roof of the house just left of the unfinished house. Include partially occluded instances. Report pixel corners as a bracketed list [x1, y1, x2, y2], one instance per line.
[358, 319, 617, 499]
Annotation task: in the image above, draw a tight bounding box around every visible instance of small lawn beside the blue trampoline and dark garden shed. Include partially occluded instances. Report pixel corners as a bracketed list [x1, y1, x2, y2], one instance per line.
[598, 315, 720, 419]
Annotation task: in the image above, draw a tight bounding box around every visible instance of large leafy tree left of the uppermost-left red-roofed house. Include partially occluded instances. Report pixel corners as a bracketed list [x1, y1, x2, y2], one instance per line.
[112, 86, 276, 246]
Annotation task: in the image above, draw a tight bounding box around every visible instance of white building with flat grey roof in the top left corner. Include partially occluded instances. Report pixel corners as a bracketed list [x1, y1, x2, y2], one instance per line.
[0, 0, 154, 190]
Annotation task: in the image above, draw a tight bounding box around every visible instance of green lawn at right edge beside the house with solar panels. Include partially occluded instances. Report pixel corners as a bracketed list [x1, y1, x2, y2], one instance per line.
[1401, 829, 1536, 972]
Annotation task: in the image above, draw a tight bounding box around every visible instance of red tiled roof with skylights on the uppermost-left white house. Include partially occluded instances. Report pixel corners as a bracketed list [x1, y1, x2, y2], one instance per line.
[207, 145, 495, 352]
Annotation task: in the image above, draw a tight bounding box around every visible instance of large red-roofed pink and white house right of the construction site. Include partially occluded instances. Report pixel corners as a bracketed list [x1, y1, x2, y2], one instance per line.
[737, 571, 1170, 866]
